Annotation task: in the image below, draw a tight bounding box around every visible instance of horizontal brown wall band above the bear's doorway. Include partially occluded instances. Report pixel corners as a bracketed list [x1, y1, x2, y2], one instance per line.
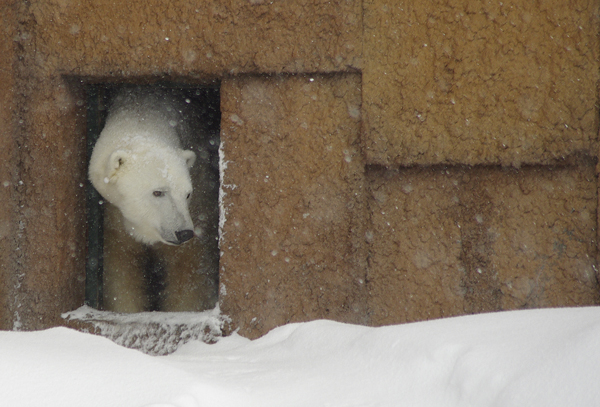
[25, 0, 362, 80]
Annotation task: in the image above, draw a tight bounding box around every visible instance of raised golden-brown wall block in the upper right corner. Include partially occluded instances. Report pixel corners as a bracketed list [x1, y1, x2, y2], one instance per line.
[363, 0, 599, 166]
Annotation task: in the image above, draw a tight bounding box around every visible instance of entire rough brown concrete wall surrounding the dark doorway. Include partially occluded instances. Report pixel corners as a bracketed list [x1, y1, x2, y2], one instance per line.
[0, 0, 600, 337]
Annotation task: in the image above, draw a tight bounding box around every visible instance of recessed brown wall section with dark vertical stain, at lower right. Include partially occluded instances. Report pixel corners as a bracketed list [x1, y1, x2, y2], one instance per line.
[368, 163, 600, 325]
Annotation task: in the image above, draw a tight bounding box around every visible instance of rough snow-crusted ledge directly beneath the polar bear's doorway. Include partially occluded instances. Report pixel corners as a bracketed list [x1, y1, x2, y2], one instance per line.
[61, 305, 230, 355]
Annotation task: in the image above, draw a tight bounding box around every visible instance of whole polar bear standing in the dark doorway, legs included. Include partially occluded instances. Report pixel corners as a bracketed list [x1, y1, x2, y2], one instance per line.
[89, 88, 218, 312]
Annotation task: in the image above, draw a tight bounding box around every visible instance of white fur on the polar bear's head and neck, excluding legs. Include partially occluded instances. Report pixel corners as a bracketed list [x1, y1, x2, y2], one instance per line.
[89, 89, 196, 244]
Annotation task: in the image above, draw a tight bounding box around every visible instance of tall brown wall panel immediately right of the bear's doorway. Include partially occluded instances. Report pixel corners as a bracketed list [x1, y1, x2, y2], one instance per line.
[220, 74, 367, 337]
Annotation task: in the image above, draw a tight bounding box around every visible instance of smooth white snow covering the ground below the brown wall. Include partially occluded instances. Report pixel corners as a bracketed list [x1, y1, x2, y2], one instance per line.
[0, 307, 600, 407]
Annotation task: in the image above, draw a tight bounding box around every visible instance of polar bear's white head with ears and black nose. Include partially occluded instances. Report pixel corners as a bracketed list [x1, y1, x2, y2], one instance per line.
[90, 141, 196, 245]
